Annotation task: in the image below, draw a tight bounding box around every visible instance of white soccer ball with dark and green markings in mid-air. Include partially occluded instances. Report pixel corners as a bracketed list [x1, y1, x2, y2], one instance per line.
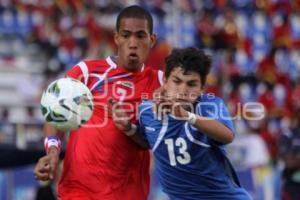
[41, 78, 93, 132]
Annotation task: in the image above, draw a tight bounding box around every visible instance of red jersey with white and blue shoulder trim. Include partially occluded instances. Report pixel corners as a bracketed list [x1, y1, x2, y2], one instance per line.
[58, 57, 162, 200]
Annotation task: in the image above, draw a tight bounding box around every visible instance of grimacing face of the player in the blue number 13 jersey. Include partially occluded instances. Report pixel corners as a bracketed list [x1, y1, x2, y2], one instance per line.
[164, 67, 202, 104]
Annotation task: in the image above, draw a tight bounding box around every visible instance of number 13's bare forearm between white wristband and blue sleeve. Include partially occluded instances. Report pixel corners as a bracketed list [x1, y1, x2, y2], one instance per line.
[193, 115, 234, 144]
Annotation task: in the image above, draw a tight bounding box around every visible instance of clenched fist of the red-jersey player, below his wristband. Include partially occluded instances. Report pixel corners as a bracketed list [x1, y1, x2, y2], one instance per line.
[34, 147, 59, 181]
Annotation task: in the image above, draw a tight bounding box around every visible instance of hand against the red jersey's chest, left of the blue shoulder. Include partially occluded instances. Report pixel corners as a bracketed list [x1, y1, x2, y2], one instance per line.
[108, 98, 131, 132]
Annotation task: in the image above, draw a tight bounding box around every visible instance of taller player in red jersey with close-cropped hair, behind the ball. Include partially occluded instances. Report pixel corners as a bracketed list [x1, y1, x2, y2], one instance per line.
[34, 6, 162, 200]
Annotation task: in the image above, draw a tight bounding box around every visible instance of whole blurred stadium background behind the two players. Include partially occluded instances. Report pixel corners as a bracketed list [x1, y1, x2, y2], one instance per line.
[0, 0, 300, 200]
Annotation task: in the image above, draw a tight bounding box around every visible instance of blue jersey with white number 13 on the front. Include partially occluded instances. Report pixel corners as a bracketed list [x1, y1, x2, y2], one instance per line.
[139, 95, 251, 200]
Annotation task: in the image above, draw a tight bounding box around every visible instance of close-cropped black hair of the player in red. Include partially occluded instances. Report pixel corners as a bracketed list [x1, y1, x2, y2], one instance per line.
[116, 5, 153, 34]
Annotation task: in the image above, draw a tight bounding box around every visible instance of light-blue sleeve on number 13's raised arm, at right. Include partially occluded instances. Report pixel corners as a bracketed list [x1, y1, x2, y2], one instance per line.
[196, 97, 235, 133]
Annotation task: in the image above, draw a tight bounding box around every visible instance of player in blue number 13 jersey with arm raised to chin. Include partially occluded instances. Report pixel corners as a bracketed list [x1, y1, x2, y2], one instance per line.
[110, 48, 251, 200]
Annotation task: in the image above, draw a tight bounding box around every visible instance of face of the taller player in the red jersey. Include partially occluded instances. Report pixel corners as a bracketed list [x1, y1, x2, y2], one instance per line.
[115, 18, 156, 71]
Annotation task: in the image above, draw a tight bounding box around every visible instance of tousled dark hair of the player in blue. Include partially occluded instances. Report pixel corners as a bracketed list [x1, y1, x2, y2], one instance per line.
[165, 47, 211, 86]
